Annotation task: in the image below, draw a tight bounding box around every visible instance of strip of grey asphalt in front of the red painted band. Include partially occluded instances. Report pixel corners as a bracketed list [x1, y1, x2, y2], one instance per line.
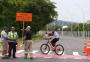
[0, 58, 90, 62]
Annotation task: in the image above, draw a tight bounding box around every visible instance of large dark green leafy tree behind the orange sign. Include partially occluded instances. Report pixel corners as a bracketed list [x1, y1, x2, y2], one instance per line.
[0, 0, 57, 36]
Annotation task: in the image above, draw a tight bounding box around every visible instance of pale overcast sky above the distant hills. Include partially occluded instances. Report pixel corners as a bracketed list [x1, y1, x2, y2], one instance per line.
[51, 0, 90, 22]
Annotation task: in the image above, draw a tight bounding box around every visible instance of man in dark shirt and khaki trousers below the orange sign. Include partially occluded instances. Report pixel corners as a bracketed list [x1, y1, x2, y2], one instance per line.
[24, 26, 32, 59]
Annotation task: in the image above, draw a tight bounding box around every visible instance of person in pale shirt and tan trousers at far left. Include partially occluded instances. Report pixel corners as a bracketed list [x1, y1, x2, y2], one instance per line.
[1, 27, 8, 59]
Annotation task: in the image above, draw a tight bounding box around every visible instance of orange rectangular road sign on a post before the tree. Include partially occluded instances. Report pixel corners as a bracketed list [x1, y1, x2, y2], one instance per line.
[16, 13, 32, 22]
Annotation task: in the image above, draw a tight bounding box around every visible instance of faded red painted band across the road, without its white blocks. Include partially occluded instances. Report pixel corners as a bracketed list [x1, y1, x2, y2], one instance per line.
[0, 53, 90, 60]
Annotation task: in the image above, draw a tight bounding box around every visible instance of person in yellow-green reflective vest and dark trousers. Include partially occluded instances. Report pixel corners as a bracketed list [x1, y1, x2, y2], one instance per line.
[8, 27, 18, 58]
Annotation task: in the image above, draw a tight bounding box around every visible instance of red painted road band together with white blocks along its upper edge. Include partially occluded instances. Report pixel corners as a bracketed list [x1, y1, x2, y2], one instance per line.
[0, 50, 90, 60]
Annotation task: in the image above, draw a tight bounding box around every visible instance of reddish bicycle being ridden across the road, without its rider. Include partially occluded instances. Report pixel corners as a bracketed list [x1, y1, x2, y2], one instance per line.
[40, 40, 64, 55]
